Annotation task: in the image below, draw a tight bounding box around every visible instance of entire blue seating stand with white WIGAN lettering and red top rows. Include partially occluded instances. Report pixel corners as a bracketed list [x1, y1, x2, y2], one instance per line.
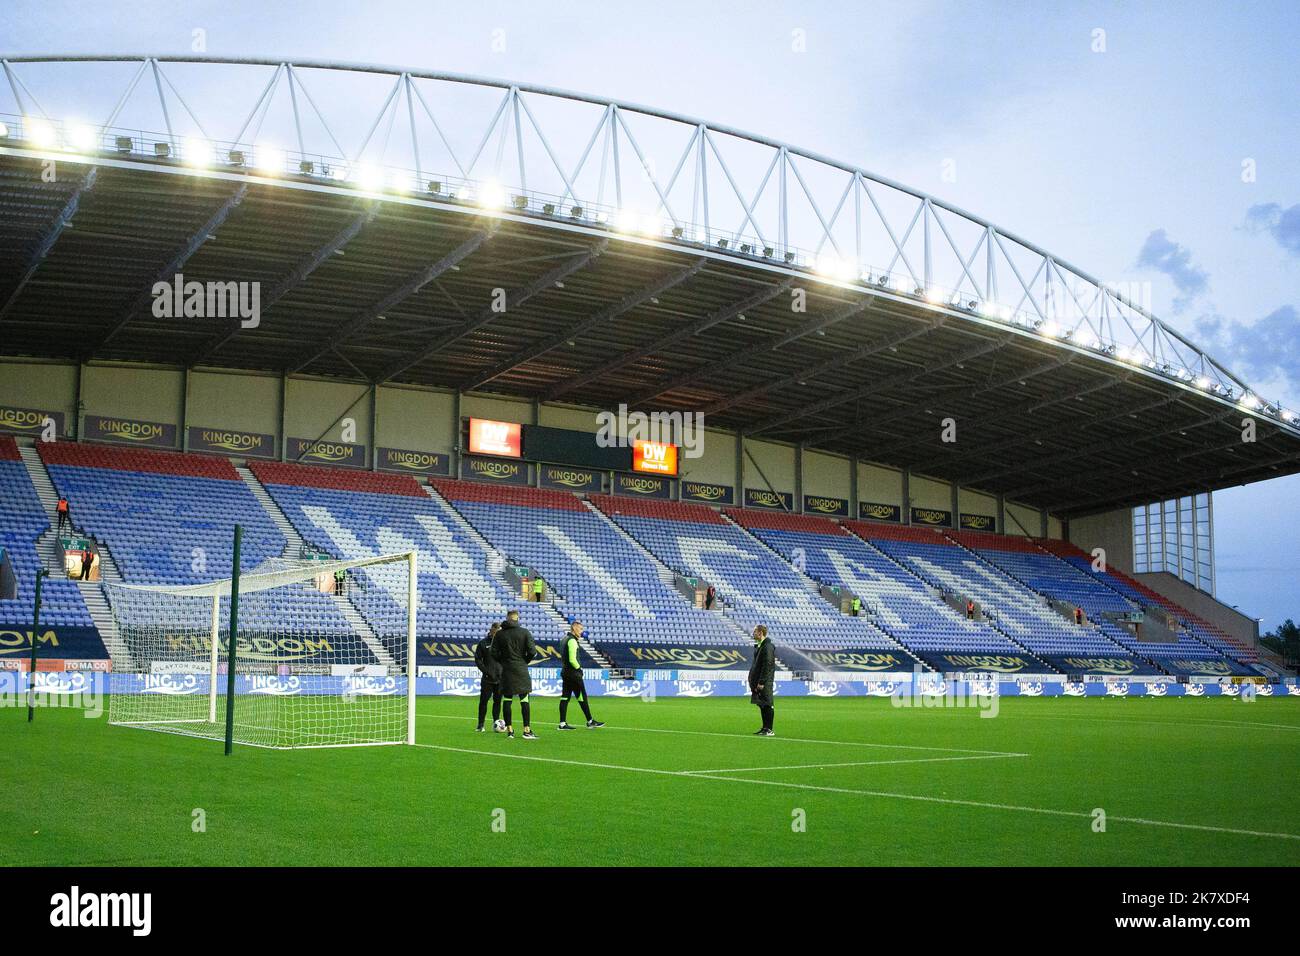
[0, 437, 1257, 676]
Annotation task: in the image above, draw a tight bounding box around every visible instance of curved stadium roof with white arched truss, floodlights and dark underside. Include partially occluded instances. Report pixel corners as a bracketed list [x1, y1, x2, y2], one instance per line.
[0, 56, 1300, 518]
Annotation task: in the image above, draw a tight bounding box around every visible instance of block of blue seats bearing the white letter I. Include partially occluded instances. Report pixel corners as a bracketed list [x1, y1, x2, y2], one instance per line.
[434, 480, 749, 666]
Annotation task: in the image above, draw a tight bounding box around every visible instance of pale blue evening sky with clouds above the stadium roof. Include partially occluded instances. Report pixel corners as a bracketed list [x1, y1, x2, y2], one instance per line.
[0, 0, 1300, 628]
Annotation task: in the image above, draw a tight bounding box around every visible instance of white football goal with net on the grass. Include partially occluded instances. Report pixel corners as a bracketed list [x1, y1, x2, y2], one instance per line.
[107, 551, 419, 748]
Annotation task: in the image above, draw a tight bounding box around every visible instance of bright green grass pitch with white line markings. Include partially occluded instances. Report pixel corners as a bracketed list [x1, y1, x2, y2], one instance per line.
[0, 697, 1300, 866]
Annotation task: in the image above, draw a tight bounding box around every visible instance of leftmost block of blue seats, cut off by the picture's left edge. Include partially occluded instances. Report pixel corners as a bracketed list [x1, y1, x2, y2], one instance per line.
[0, 436, 108, 659]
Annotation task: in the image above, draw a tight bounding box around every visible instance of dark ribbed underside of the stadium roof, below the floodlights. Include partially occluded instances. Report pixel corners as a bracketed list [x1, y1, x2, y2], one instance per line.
[0, 156, 1300, 516]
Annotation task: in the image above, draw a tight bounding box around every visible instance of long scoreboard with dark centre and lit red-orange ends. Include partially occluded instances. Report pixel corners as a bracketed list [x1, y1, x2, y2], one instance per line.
[463, 419, 680, 477]
